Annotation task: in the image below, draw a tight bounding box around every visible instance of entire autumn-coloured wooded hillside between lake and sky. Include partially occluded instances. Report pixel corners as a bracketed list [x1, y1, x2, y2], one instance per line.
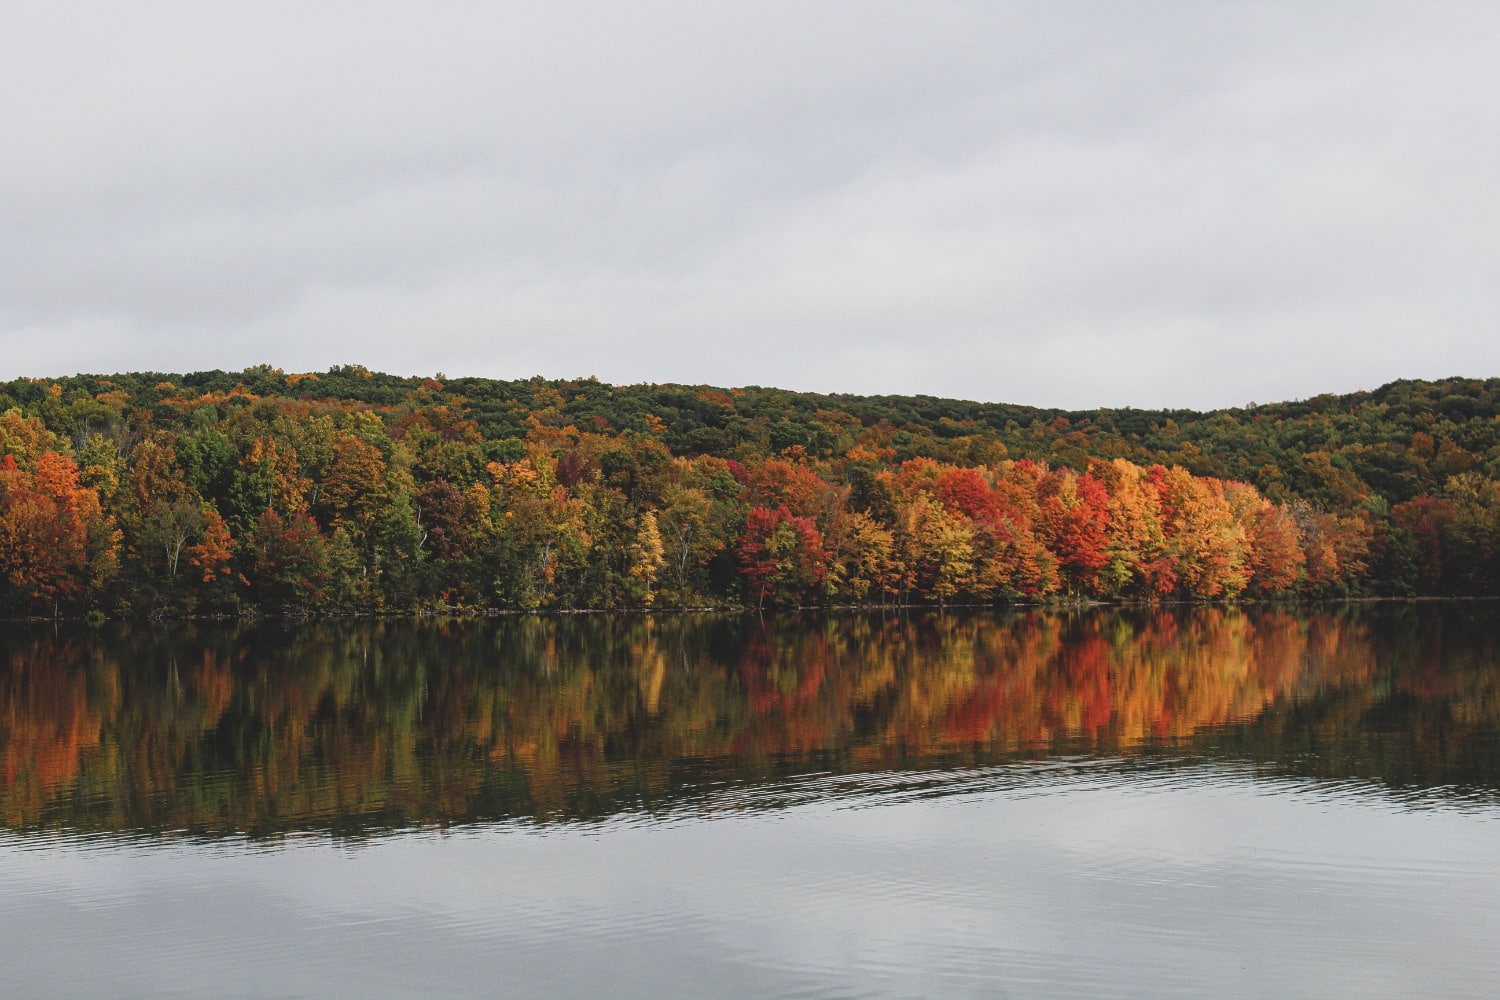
[0, 366, 1500, 615]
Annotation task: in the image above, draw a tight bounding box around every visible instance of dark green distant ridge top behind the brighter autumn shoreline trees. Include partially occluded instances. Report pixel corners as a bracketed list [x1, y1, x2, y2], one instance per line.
[0, 364, 1500, 502]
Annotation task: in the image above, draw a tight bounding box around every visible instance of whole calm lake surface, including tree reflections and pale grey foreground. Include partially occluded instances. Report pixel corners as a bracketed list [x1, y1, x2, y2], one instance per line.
[0, 604, 1500, 997]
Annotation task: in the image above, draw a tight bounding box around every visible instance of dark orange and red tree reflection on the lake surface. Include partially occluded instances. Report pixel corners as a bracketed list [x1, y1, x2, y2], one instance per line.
[0, 604, 1500, 835]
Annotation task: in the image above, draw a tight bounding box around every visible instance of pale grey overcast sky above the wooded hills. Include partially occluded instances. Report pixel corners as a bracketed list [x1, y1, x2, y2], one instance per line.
[0, 0, 1500, 409]
